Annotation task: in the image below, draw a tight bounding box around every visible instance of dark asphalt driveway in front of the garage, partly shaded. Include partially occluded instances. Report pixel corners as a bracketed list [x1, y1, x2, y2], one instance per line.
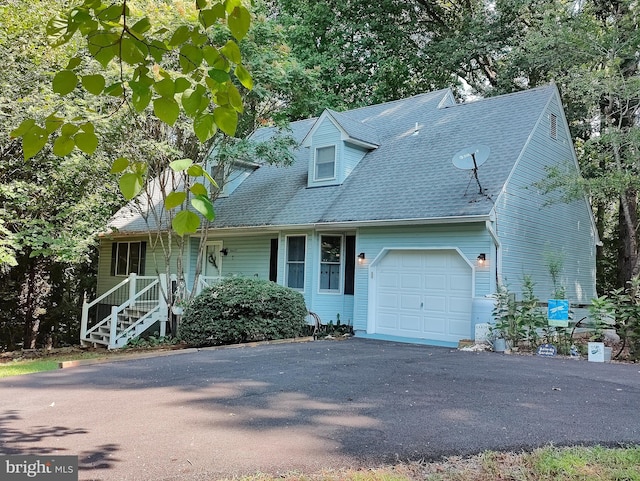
[0, 339, 640, 481]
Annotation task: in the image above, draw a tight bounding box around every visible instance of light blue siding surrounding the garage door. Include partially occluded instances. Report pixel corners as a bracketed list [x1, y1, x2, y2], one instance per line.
[354, 223, 495, 331]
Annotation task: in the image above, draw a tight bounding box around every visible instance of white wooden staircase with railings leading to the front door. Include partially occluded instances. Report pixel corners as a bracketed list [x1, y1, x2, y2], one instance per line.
[80, 274, 168, 349]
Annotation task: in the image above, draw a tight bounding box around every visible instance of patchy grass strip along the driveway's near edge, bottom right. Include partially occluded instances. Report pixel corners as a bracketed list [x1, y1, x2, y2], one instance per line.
[218, 446, 640, 481]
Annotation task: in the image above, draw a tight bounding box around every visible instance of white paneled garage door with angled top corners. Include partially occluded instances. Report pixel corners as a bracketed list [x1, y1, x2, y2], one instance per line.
[374, 250, 472, 342]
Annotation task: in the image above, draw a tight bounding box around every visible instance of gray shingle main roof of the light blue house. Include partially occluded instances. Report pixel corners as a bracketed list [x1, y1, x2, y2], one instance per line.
[113, 86, 556, 231]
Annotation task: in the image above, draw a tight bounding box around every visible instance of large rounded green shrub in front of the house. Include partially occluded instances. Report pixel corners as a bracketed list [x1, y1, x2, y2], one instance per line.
[179, 277, 307, 346]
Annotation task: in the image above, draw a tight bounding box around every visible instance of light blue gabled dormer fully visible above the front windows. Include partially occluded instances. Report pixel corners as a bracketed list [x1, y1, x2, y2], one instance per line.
[301, 109, 380, 187]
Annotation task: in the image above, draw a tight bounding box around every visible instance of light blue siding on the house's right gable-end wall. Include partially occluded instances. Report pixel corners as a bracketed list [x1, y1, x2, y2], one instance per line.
[495, 97, 597, 304]
